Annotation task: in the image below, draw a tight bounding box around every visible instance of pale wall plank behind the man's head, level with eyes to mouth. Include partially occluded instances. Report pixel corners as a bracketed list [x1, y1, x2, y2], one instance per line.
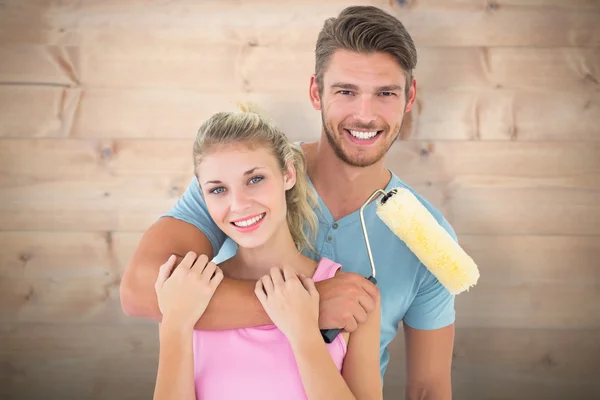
[0, 86, 600, 142]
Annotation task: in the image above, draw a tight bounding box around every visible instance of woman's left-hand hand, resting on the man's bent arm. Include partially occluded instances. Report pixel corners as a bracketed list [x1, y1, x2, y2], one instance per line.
[154, 252, 223, 330]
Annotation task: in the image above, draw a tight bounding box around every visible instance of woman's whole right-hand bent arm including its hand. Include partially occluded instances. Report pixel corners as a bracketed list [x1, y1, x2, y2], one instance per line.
[255, 267, 382, 400]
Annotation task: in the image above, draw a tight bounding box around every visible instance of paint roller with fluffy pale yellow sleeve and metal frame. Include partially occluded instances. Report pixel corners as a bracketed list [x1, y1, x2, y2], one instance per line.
[321, 188, 479, 343]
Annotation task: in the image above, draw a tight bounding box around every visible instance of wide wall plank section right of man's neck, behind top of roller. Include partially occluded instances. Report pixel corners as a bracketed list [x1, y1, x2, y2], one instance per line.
[387, 142, 600, 235]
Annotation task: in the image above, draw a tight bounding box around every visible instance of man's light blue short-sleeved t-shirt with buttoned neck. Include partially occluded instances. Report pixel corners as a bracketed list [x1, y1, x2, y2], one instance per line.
[165, 174, 456, 378]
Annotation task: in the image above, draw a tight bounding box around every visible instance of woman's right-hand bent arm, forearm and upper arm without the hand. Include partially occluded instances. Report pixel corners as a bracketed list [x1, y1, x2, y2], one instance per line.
[291, 298, 383, 400]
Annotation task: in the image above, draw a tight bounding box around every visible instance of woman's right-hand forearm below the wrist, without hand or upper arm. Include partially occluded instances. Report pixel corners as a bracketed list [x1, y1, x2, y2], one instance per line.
[290, 329, 356, 400]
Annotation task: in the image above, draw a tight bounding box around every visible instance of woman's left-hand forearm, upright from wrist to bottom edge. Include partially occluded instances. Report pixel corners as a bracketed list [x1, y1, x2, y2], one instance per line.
[154, 321, 196, 400]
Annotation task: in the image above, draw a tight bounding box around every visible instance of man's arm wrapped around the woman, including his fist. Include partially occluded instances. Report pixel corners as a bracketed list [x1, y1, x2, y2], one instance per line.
[120, 217, 378, 332]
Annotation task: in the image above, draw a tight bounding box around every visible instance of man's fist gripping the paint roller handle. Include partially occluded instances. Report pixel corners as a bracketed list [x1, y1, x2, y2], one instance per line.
[315, 271, 379, 332]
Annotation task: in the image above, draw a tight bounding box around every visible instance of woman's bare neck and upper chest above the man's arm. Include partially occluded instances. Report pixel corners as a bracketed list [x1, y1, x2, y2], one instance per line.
[231, 222, 317, 279]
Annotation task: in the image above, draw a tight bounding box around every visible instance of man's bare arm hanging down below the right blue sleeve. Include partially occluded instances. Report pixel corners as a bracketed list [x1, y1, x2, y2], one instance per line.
[404, 324, 454, 400]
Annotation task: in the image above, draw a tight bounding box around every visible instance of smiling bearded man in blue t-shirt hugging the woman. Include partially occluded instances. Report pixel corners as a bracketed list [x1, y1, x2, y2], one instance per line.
[121, 7, 455, 400]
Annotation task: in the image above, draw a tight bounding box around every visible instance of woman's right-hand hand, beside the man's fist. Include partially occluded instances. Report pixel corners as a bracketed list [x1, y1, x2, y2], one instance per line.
[254, 267, 319, 341]
